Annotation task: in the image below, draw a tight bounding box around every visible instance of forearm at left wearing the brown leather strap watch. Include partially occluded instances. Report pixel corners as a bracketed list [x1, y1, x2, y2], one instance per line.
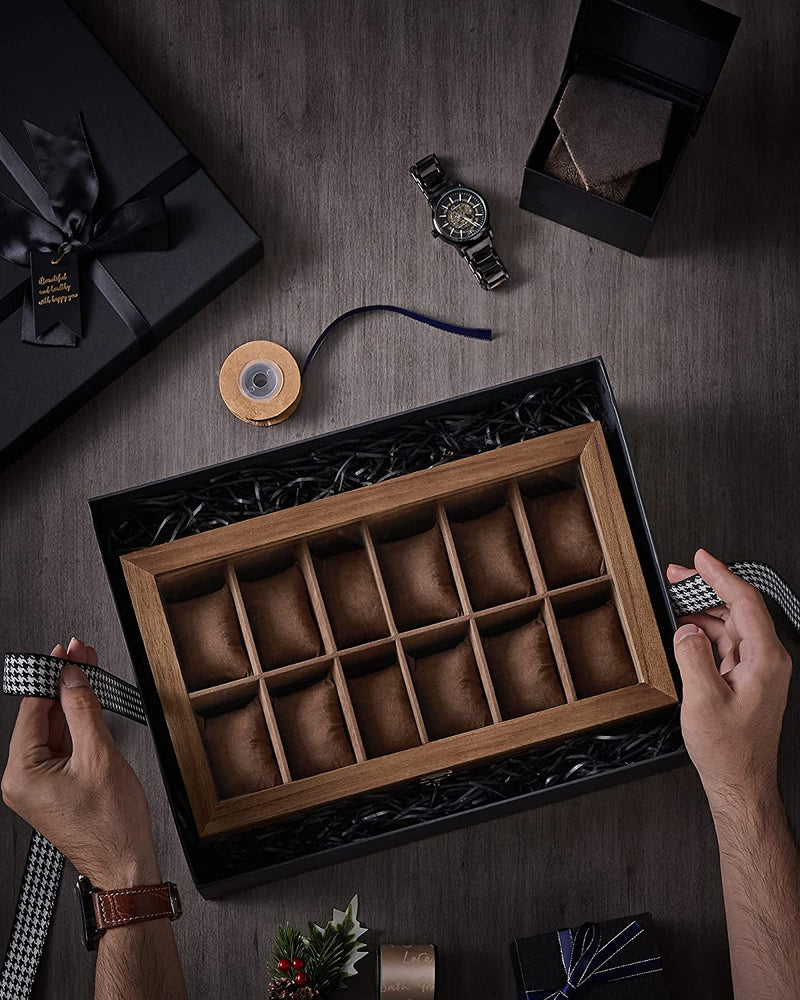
[95, 850, 186, 1000]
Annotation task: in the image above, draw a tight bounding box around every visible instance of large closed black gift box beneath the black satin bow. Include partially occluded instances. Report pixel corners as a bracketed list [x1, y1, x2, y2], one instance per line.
[0, 0, 263, 465]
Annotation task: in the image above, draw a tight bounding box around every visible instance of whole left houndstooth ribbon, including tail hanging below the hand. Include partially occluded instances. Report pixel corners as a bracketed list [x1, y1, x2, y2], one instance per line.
[0, 653, 147, 1000]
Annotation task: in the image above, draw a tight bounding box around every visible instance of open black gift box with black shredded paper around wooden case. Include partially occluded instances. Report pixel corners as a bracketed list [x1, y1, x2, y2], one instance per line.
[90, 358, 687, 897]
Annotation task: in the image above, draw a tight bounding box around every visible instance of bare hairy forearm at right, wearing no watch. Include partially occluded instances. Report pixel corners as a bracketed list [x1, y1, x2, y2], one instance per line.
[711, 786, 800, 1000]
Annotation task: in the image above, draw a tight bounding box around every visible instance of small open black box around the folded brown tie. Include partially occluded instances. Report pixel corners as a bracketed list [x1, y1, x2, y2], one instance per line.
[520, 0, 740, 254]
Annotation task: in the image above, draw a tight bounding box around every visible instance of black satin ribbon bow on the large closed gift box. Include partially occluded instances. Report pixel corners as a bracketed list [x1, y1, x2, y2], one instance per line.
[0, 115, 169, 347]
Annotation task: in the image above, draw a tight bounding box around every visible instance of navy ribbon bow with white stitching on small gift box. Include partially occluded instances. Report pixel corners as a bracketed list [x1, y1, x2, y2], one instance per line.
[525, 920, 662, 1000]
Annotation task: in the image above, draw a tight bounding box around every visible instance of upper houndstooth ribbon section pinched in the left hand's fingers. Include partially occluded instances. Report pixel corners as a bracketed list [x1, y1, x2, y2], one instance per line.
[3, 653, 147, 725]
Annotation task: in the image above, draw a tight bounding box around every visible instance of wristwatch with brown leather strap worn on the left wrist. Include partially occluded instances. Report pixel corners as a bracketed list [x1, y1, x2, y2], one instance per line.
[75, 875, 183, 951]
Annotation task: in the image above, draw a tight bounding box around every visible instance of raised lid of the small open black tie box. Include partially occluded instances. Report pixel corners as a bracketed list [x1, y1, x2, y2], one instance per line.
[567, 0, 741, 97]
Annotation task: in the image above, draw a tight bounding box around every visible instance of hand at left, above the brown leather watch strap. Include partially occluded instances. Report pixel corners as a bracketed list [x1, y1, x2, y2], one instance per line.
[2, 639, 161, 889]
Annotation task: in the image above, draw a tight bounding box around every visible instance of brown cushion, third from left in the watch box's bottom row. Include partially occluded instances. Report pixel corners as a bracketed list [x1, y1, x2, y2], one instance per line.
[347, 664, 420, 757]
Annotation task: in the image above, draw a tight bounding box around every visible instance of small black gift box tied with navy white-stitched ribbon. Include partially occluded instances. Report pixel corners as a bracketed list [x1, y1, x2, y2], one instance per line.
[511, 913, 667, 1000]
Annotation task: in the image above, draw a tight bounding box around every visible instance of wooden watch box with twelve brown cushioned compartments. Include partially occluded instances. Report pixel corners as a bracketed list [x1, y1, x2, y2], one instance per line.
[121, 422, 677, 839]
